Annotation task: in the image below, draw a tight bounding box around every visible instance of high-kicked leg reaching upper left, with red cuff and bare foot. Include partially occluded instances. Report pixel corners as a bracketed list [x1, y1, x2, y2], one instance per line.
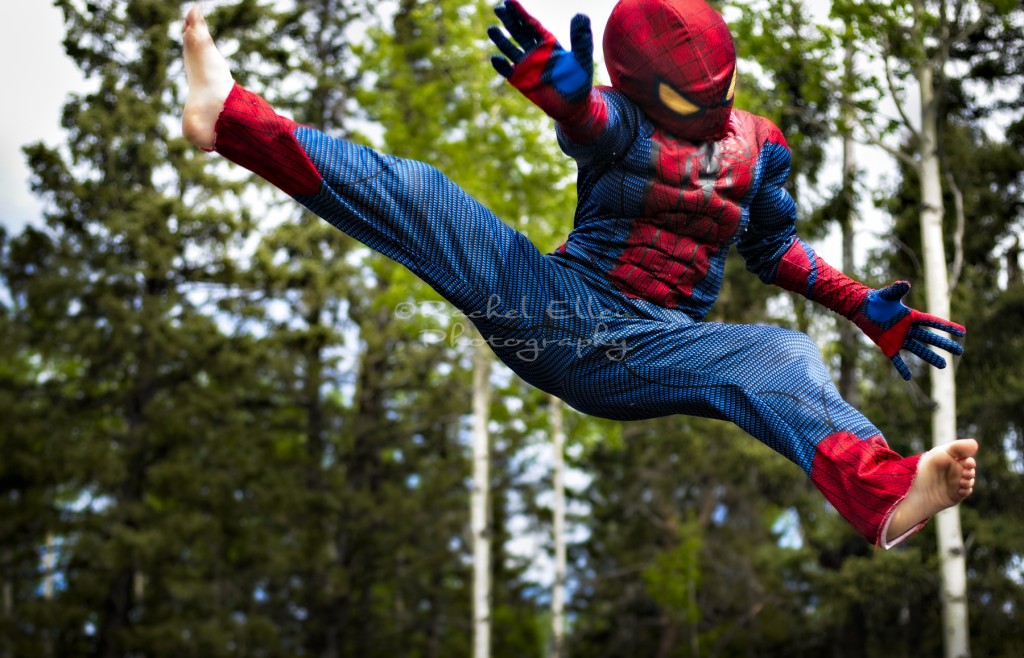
[182, 9, 601, 394]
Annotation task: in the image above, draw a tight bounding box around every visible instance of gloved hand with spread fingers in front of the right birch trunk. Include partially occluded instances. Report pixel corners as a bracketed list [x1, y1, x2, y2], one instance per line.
[851, 281, 967, 380]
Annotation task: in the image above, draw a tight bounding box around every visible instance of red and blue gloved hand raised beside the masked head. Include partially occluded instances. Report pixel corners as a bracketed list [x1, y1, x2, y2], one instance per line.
[487, 0, 594, 122]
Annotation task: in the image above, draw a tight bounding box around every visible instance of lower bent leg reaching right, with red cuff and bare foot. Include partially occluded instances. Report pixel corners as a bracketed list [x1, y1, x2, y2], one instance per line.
[568, 320, 977, 546]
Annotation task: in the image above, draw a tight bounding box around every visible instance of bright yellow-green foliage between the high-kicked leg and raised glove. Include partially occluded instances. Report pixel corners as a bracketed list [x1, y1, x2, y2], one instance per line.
[358, 0, 575, 250]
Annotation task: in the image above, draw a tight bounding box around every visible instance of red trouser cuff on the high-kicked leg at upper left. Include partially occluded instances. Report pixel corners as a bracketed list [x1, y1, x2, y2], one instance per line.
[207, 85, 323, 196]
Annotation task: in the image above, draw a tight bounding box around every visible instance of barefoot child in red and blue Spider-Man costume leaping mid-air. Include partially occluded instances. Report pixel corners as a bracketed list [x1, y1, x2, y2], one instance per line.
[183, 0, 977, 546]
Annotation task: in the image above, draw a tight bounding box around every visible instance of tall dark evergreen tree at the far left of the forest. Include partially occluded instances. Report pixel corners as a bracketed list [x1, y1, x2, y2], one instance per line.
[3, 0, 280, 656]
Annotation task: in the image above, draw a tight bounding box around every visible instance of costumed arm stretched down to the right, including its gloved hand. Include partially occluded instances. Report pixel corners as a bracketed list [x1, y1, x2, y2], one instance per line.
[739, 134, 965, 380]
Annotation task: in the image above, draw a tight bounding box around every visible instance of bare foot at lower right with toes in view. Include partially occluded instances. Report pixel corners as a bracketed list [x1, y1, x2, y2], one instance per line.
[886, 439, 978, 541]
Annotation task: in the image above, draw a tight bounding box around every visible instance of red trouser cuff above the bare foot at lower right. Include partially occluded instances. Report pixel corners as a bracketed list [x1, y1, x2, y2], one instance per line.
[811, 432, 925, 547]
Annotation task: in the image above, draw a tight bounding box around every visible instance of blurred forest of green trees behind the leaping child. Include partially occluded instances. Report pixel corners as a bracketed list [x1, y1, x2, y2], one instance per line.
[0, 0, 1024, 658]
